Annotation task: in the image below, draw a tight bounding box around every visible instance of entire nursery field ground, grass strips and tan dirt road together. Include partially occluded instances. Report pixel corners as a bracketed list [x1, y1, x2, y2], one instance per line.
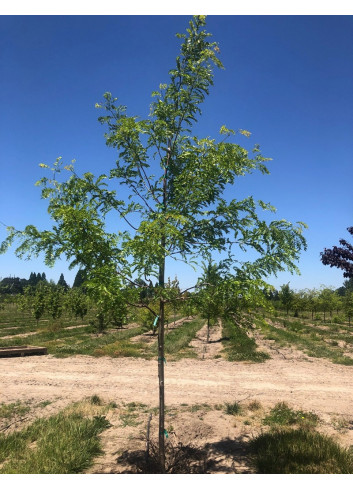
[0, 309, 353, 474]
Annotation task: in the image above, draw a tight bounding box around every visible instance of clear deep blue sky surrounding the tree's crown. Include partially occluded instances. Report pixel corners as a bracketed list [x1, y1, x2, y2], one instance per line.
[0, 15, 353, 289]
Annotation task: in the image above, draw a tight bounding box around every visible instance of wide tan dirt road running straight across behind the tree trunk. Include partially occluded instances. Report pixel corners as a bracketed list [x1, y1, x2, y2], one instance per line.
[0, 348, 353, 415]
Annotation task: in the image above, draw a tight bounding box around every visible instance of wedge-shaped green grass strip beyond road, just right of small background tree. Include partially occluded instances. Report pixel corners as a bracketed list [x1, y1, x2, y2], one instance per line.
[222, 320, 270, 362]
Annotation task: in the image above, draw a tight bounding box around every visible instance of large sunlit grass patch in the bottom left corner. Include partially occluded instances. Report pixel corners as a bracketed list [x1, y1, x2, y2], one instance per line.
[0, 402, 110, 474]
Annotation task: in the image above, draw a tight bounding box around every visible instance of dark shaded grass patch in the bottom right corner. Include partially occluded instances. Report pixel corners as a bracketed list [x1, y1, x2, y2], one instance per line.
[250, 429, 353, 474]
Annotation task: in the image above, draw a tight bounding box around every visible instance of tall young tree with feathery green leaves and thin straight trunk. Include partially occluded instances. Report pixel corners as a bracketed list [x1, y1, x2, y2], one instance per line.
[2, 16, 306, 471]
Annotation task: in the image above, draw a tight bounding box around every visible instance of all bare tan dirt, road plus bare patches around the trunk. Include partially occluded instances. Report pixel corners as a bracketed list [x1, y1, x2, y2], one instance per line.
[0, 318, 353, 473]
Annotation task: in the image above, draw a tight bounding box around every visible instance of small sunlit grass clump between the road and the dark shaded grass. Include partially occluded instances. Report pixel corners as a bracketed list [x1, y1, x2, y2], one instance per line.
[263, 402, 319, 428]
